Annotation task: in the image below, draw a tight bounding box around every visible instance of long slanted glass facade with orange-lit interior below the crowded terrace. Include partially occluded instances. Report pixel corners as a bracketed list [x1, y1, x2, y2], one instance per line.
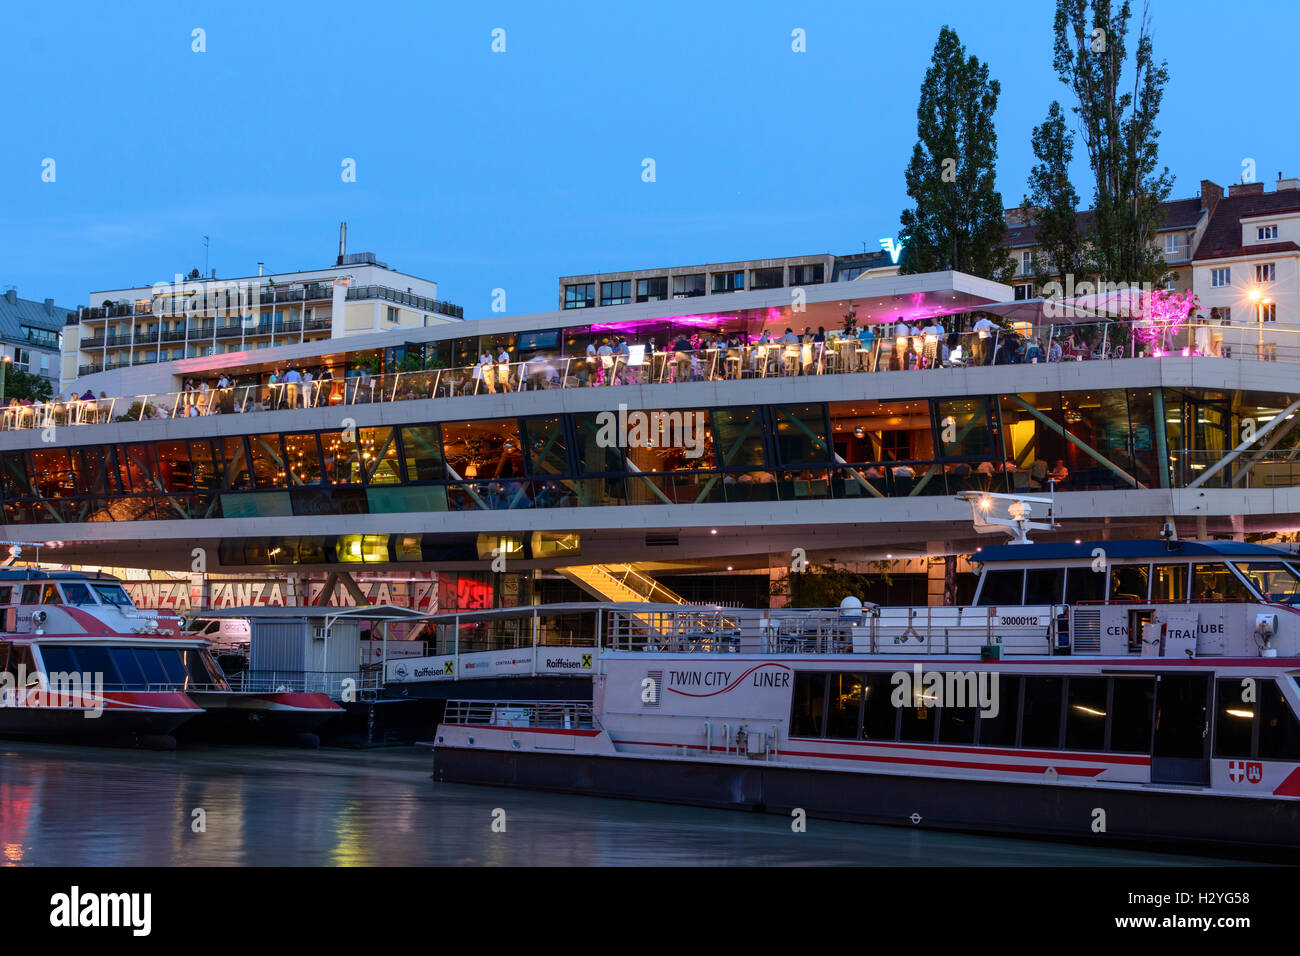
[0, 389, 1300, 522]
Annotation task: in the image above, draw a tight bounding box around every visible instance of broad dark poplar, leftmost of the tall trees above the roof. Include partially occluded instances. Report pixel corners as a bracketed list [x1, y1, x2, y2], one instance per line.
[898, 26, 1014, 281]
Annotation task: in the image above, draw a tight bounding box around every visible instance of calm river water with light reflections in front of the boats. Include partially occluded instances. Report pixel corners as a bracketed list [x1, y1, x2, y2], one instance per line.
[0, 743, 1237, 866]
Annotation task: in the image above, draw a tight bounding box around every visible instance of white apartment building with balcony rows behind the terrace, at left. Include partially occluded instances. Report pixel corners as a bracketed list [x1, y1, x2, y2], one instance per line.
[59, 224, 464, 390]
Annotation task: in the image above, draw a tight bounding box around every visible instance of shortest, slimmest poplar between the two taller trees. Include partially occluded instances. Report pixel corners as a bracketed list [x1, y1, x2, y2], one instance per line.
[1022, 100, 1084, 286]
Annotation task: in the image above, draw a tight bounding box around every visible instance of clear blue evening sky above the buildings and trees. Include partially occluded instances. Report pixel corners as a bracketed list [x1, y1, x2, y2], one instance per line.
[0, 0, 1300, 317]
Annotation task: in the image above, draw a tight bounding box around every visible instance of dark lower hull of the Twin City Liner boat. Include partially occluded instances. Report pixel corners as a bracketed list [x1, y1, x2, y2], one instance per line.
[433, 745, 1300, 860]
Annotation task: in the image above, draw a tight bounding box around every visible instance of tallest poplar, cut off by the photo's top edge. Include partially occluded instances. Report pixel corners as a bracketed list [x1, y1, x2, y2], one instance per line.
[1053, 0, 1174, 284]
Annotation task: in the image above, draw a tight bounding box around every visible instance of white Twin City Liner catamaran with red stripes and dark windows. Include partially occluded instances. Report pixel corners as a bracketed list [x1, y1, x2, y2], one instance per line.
[425, 540, 1300, 852]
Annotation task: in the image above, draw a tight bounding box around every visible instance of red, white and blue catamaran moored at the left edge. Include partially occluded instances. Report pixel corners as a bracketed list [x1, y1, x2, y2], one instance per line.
[0, 568, 342, 748]
